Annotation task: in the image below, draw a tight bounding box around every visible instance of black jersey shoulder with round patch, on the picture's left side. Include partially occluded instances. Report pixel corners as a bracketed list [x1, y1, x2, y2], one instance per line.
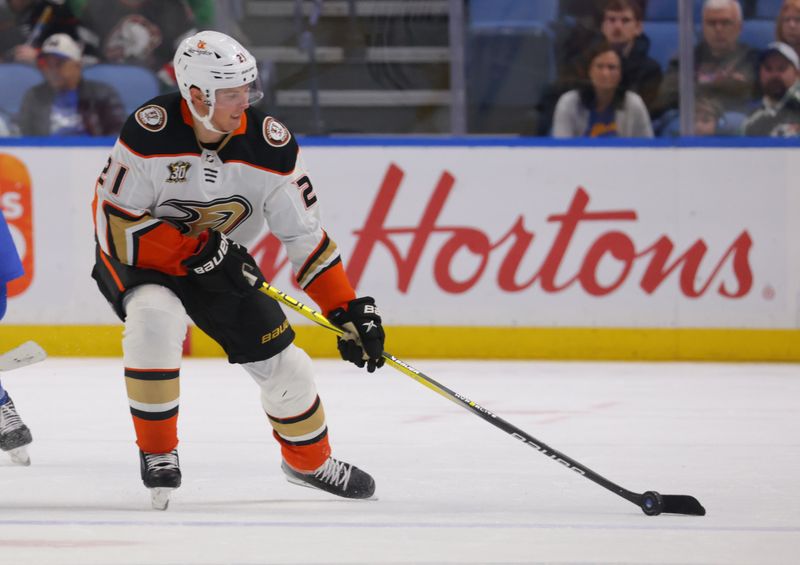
[119, 92, 200, 157]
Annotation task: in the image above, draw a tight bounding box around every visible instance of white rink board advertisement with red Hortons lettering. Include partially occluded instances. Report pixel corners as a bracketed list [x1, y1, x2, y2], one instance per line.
[0, 146, 800, 328]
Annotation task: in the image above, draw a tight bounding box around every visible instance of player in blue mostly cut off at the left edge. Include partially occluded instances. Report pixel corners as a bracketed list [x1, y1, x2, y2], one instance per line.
[0, 212, 33, 465]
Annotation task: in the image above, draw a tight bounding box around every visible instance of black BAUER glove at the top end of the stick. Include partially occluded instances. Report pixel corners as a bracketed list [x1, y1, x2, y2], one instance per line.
[183, 229, 264, 292]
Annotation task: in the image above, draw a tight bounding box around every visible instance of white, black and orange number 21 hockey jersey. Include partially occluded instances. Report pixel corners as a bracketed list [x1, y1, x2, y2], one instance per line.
[94, 93, 355, 313]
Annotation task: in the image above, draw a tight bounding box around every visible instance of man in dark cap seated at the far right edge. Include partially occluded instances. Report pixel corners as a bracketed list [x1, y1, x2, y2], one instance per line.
[744, 41, 800, 137]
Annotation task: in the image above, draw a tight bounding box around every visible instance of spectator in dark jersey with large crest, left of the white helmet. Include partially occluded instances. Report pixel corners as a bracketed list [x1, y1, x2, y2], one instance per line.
[81, 0, 197, 89]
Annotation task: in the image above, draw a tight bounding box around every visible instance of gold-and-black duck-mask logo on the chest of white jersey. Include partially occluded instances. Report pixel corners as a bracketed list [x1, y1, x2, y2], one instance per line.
[158, 196, 253, 236]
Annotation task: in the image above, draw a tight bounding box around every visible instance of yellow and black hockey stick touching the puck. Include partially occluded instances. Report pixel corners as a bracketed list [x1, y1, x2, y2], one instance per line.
[259, 282, 706, 516]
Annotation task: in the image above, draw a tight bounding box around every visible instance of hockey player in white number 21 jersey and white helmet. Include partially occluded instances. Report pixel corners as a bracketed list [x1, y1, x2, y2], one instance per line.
[92, 31, 384, 508]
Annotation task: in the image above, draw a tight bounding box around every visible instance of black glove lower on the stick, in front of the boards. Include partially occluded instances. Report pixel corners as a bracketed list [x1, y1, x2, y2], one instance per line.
[328, 296, 386, 373]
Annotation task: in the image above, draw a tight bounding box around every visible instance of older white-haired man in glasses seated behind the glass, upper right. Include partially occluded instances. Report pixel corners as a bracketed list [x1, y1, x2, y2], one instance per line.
[653, 0, 758, 116]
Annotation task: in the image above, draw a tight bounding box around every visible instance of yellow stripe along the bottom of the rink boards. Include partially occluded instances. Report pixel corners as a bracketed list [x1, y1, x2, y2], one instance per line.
[0, 325, 800, 362]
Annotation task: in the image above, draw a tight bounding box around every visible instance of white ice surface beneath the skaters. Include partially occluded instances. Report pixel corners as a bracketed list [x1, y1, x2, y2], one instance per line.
[0, 359, 800, 565]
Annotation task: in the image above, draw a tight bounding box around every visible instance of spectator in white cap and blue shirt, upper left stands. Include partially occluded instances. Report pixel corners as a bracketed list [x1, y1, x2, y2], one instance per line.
[19, 33, 126, 136]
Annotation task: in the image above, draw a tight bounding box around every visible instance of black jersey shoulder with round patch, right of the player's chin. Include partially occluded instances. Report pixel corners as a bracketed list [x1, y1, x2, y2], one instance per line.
[219, 108, 299, 175]
